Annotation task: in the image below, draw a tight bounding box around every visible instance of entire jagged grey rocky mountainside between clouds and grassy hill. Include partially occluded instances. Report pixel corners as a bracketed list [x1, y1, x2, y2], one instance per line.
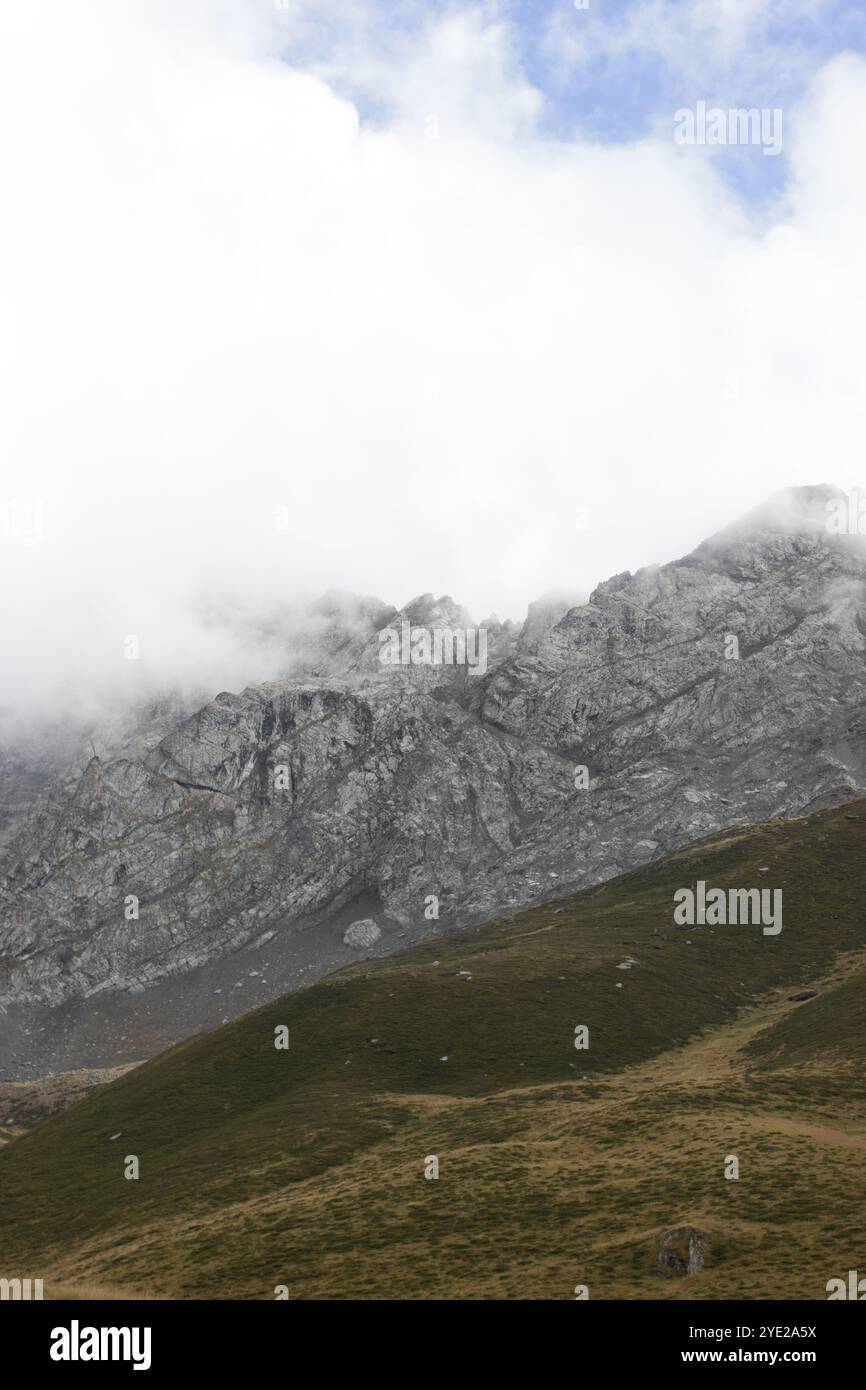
[0, 491, 866, 1062]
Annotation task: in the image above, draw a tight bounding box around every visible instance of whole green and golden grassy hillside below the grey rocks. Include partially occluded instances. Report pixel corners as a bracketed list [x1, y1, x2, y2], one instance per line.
[0, 802, 866, 1298]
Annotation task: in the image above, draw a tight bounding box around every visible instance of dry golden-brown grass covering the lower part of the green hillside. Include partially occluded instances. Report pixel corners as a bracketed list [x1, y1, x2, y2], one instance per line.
[18, 954, 866, 1298]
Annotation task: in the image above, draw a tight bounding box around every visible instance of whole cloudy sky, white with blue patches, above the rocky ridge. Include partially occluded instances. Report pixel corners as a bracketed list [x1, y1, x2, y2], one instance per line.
[0, 0, 866, 703]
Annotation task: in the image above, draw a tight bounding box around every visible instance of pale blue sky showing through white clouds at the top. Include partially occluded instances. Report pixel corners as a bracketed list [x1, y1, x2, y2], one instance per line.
[285, 0, 866, 203]
